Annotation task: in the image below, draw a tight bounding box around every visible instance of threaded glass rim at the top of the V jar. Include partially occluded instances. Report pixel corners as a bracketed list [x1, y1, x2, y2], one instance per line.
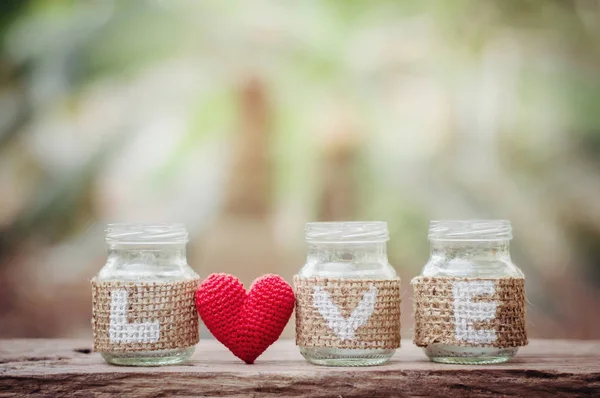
[304, 221, 389, 243]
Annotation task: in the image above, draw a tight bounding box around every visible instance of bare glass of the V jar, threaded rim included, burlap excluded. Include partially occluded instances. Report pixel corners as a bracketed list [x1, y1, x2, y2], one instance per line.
[297, 221, 398, 366]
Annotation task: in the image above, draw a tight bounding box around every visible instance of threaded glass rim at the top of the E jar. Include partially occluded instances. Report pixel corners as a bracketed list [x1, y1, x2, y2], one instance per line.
[429, 220, 512, 241]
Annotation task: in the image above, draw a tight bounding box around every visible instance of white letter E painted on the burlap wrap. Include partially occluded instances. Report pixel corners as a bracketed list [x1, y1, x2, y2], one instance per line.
[453, 281, 498, 344]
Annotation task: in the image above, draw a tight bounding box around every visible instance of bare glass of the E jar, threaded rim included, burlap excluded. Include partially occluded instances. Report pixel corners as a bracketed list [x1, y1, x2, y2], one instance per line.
[421, 220, 524, 364]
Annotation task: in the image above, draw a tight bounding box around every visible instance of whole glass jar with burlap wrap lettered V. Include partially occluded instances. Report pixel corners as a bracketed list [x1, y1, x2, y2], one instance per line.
[294, 222, 400, 366]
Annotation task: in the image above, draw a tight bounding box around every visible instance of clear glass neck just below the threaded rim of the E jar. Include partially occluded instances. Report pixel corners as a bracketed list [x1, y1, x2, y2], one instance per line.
[430, 240, 510, 260]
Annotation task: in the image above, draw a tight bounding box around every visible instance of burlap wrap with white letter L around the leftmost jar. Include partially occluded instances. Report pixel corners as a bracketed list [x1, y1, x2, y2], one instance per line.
[91, 278, 200, 352]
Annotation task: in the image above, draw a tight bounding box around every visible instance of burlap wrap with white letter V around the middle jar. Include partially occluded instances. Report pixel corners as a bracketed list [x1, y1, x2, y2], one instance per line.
[294, 276, 401, 349]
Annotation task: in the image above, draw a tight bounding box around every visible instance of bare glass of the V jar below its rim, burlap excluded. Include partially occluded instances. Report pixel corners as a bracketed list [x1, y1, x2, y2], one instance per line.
[298, 241, 397, 366]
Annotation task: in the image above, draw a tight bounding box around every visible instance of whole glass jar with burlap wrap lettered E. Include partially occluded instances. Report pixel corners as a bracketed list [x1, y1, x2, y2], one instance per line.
[411, 220, 527, 364]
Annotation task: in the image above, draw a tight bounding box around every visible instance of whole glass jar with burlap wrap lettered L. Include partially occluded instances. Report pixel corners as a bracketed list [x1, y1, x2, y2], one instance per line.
[92, 224, 200, 366]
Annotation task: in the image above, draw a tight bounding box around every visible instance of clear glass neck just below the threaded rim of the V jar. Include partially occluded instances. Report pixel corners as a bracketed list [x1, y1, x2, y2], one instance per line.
[307, 241, 387, 265]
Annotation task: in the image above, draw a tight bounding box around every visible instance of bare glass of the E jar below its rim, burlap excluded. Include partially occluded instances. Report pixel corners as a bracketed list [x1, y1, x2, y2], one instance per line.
[421, 240, 524, 364]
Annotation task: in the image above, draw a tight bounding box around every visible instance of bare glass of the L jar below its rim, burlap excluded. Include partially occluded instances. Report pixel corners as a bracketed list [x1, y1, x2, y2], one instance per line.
[96, 239, 198, 366]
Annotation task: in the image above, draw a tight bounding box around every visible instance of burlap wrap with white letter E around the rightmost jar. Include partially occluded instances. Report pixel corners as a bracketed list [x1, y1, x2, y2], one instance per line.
[411, 276, 527, 348]
